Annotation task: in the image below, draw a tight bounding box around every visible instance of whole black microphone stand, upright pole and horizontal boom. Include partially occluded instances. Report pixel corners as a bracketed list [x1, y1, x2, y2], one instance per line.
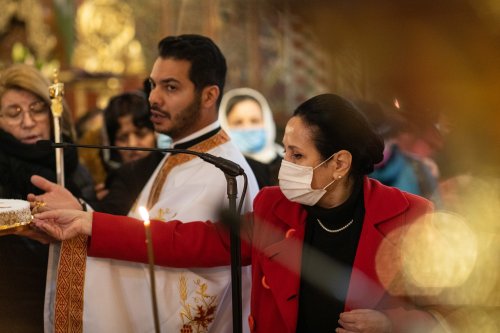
[37, 140, 246, 333]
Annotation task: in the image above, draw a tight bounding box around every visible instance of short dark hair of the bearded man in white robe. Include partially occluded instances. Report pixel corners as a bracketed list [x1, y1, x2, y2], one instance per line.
[158, 35, 227, 106]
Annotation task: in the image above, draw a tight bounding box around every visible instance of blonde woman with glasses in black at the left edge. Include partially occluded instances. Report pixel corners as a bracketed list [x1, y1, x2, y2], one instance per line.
[0, 64, 93, 332]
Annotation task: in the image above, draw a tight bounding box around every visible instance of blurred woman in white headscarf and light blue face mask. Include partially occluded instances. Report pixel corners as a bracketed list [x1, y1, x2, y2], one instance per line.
[219, 88, 283, 188]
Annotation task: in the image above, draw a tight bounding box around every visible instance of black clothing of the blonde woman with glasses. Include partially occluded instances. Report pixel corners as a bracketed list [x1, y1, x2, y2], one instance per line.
[0, 130, 93, 333]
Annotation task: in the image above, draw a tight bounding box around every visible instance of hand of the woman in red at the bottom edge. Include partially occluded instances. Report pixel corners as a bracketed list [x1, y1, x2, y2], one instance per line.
[335, 309, 392, 333]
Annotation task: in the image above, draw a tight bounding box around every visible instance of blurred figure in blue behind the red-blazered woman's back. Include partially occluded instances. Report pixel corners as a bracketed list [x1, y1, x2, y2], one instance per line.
[356, 101, 440, 204]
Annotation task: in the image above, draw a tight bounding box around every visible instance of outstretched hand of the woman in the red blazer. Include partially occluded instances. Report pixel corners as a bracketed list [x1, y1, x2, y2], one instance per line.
[32, 209, 92, 240]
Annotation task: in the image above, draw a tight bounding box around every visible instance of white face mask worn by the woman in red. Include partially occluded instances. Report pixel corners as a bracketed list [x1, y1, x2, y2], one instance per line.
[278, 153, 336, 206]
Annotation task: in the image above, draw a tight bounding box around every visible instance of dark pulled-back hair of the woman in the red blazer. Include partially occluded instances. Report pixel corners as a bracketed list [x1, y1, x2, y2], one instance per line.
[293, 94, 384, 176]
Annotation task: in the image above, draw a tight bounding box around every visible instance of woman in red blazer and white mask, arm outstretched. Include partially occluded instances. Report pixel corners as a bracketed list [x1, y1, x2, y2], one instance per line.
[34, 94, 437, 333]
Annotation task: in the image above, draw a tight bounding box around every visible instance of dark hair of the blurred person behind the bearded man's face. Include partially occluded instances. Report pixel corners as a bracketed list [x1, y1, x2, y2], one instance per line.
[104, 92, 154, 145]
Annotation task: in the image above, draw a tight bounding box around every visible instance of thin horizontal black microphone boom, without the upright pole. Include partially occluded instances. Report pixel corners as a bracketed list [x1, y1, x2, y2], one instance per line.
[36, 140, 245, 177]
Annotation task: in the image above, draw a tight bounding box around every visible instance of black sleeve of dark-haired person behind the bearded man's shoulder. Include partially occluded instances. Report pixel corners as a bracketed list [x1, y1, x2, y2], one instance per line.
[91, 152, 164, 215]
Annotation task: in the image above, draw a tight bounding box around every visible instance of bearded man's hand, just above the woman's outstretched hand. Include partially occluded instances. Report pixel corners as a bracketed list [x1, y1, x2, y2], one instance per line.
[28, 175, 83, 211]
